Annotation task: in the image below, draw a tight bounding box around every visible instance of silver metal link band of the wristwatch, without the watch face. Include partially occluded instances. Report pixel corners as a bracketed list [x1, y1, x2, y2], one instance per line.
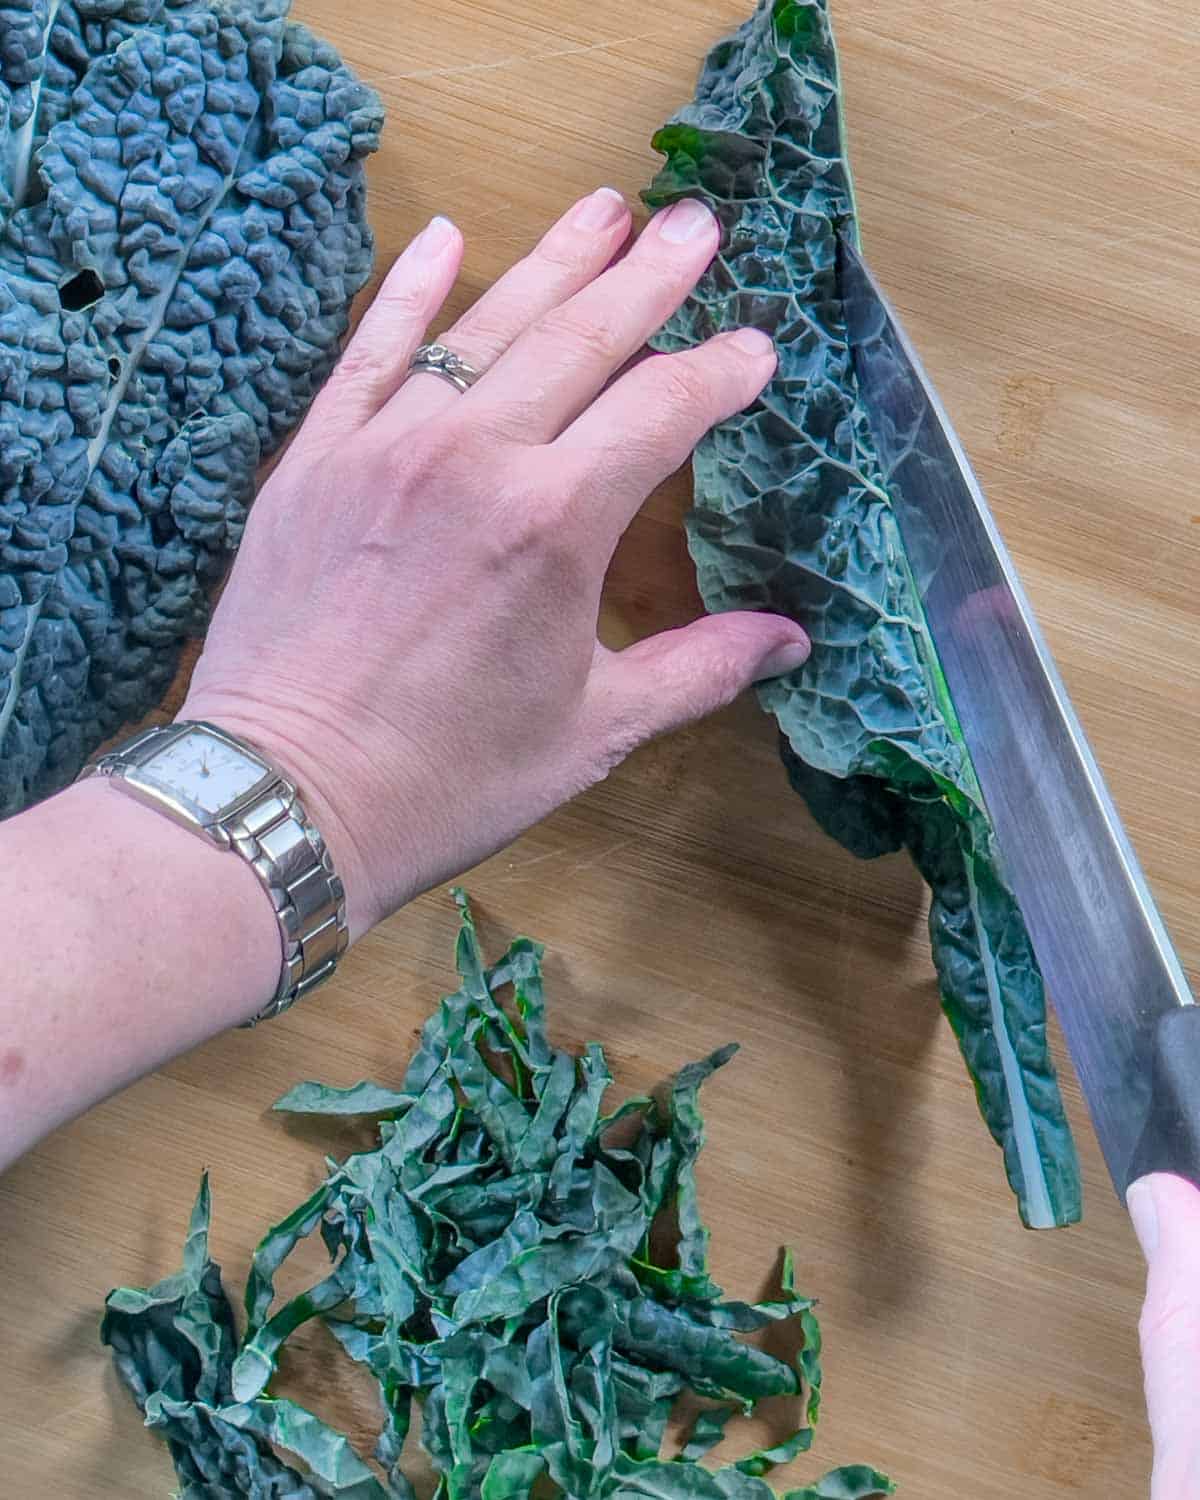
[221, 777, 350, 1026]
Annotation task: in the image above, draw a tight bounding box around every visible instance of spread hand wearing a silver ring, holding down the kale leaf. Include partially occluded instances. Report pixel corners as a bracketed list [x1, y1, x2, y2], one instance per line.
[183, 189, 809, 936]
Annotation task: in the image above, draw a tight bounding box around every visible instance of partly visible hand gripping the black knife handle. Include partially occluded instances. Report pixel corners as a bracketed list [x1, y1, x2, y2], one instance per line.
[1127, 1173, 1200, 1500]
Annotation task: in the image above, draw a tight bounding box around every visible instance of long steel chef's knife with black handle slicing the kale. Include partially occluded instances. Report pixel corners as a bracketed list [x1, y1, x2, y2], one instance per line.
[840, 236, 1200, 1197]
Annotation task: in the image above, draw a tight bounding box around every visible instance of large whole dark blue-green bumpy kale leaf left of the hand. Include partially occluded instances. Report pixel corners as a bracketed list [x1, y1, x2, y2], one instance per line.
[0, 0, 383, 815]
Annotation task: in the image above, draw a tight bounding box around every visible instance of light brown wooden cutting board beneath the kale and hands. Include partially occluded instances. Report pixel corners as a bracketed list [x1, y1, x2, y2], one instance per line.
[0, 0, 1200, 1500]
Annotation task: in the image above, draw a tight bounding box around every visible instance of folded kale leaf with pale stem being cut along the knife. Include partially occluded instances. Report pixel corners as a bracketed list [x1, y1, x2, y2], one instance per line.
[647, 0, 1082, 1227]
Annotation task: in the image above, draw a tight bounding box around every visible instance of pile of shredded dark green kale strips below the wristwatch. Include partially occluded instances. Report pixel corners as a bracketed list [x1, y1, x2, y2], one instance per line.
[102, 897, 891, 1500]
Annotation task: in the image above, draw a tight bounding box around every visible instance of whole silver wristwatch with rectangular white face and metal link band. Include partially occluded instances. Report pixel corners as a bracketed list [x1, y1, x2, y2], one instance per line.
[80, 722, 350, 1026]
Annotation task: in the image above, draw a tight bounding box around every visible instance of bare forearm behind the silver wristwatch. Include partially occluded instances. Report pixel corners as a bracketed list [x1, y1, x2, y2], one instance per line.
[0, 782, 281, 1169]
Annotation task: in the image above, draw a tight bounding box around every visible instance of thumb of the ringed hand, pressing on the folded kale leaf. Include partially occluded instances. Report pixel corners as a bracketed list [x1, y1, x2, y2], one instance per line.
[596, 611, 812, 749]
